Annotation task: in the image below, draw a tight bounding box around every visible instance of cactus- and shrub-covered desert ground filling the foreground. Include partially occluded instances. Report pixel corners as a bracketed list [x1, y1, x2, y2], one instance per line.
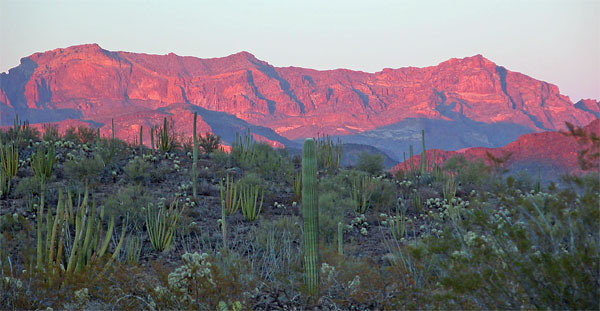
[0, 119, 600, 310]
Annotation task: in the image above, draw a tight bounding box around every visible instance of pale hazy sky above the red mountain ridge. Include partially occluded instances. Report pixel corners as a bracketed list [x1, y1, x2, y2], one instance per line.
[0, 0, 600, 101]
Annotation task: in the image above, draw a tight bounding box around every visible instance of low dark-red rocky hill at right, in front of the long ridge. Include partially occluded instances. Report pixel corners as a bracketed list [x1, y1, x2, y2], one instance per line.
[392, 119, 600, 180]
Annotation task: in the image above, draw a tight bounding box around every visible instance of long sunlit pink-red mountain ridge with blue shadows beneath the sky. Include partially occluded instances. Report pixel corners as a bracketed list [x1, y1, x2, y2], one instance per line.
[0, 44, 600, 160]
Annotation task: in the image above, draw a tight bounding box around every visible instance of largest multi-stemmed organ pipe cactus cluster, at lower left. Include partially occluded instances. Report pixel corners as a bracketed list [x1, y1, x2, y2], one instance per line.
[37, 187, 126, 283]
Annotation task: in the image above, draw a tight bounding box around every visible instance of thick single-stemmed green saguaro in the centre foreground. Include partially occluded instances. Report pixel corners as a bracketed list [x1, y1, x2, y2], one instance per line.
[302, 138, 319, 294]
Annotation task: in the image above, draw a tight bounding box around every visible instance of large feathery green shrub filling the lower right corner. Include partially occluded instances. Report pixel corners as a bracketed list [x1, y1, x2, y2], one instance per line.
[386, 176, 600, 310]
